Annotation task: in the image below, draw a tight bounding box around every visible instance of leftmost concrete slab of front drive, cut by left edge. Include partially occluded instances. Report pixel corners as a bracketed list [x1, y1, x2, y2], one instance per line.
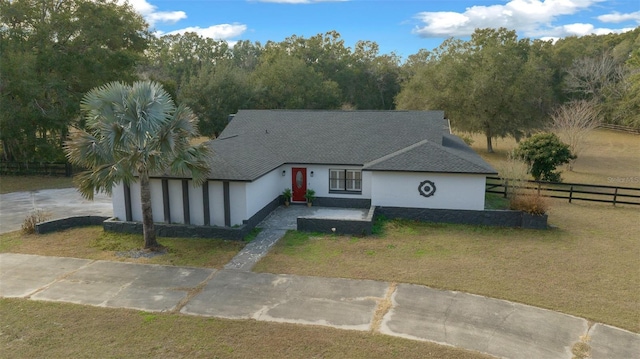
[0, 253, 92, 298]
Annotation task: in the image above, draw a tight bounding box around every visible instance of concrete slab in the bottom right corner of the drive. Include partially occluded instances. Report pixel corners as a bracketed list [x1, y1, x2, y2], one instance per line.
[589, 324, 640, 359]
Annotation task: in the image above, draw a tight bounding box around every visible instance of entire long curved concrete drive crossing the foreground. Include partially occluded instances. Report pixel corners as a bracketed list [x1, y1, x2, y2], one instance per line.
[0, 253, 640, 359]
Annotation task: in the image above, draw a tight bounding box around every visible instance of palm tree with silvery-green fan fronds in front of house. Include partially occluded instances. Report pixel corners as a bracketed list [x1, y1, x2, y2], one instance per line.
[65, 81, 210, 249]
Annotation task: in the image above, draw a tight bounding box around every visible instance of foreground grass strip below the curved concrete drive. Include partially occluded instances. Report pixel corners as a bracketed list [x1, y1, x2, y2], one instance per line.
[0, 299, 490, 359]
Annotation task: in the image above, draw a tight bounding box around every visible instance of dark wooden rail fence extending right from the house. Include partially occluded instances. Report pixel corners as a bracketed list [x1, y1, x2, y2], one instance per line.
[486, 177, 640, 206]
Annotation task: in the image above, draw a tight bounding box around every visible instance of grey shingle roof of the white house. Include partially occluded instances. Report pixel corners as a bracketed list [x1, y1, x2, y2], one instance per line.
[210, 110, 495, 181]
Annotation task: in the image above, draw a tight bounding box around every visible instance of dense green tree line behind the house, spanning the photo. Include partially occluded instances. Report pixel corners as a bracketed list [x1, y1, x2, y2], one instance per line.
[0, 0, 640, 162]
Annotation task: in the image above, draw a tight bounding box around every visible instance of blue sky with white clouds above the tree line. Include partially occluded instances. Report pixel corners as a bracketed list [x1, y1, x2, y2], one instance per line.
[119, 0, 640, 58]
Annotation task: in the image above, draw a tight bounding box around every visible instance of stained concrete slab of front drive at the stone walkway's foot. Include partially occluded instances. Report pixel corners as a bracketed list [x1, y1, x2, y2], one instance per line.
[181, 270, 389, 330]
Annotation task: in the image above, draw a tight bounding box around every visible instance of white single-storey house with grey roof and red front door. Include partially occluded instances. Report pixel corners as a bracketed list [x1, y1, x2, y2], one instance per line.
[113, 110, 496, 235]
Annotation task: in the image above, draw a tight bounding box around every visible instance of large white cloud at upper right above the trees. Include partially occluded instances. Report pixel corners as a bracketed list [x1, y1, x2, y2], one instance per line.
[413, 0, 640, 38]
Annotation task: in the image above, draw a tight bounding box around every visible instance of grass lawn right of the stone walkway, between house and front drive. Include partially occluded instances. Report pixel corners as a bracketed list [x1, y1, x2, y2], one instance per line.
[254, 201, 640, 332]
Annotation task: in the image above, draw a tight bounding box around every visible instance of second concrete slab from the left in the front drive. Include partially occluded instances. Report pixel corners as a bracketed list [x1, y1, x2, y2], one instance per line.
[32, 261, 215, 311]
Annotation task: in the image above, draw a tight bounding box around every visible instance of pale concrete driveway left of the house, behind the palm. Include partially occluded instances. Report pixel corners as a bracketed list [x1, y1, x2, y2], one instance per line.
[0, 188, 113, 233]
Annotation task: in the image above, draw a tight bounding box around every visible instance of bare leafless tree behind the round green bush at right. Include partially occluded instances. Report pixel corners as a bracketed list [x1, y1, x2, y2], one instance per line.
[551, 100, 601, 171]
